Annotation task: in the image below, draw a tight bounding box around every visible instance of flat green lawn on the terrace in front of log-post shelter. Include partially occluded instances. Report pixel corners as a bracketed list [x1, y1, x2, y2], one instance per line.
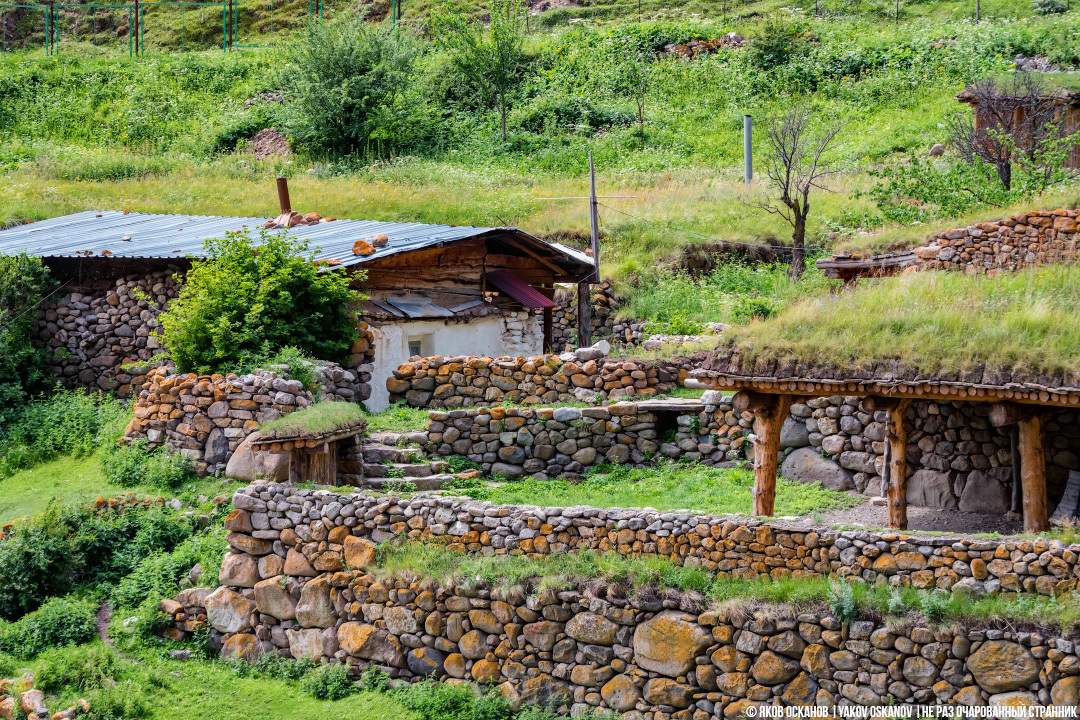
[451, 464, 862, 515]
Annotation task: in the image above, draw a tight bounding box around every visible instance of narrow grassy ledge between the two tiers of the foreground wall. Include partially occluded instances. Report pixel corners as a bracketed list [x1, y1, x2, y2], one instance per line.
[374, 542, 1080, 631]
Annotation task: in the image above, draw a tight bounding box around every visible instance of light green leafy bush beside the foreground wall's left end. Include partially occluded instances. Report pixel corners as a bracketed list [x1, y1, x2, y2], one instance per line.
[112, 528, 226, 608]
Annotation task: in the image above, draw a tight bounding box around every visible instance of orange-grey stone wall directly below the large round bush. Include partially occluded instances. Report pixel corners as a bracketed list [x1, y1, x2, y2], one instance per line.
[124, 363, 370, 475]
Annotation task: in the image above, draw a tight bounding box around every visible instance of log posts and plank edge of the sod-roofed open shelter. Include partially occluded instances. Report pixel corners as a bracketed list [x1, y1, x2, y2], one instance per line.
[691, 369, 1080, 532]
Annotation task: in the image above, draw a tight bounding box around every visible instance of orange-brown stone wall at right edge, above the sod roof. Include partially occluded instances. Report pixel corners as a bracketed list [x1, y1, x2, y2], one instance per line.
[915, 209, 1080, 274]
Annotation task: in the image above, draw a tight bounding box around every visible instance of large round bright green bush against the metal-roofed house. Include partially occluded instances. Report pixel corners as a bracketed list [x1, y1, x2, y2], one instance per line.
[160, 230, 363, 373]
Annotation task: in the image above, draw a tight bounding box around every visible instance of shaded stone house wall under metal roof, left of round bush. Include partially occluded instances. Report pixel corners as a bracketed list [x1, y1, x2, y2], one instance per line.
[38, 266, 180, 397]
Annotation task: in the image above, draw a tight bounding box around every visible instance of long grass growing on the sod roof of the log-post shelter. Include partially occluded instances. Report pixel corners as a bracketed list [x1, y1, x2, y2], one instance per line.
[726, 266, 1080, 384]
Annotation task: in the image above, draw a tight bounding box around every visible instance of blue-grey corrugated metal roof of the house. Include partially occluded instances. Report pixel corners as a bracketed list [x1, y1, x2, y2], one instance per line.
[0, 210, 588, 276]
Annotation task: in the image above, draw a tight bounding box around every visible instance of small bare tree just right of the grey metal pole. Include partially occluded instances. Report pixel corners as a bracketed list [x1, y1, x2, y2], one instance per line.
[750, 107, 840, 277]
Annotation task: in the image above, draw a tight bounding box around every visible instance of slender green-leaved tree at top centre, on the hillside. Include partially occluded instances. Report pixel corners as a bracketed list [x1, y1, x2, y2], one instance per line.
[429, 0, 526, 140]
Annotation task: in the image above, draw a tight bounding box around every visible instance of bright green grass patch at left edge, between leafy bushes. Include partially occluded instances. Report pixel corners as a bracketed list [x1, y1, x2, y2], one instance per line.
[0, 453, 224, 525]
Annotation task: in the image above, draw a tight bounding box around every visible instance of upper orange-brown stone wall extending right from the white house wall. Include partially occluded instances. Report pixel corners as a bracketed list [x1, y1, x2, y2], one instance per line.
[387, 348, 677, 408]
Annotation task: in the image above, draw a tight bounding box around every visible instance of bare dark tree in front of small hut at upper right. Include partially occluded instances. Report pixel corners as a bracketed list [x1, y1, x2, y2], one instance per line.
[947, 72, 1066, 190]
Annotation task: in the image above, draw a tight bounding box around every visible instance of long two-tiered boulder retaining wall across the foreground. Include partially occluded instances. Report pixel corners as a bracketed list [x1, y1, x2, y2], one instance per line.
[164, 484, 1080, 720]
